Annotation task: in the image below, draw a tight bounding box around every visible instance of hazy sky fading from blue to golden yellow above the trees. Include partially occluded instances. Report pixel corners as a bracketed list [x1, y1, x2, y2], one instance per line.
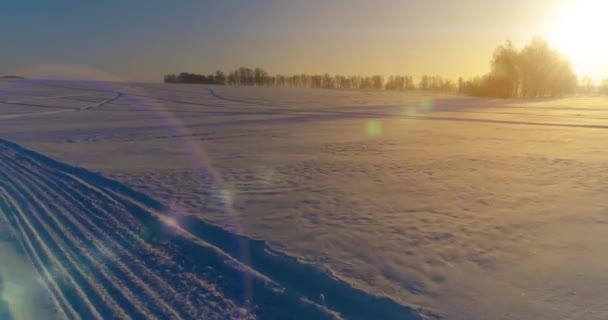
[0, 0, 599, 82]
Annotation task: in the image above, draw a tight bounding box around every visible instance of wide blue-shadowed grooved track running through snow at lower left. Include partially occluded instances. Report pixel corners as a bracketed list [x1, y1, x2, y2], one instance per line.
[0, 140, 426, 319]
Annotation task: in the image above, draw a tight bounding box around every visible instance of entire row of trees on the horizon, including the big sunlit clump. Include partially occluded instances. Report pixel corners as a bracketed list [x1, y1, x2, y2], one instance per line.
[164, 38, 608, 98]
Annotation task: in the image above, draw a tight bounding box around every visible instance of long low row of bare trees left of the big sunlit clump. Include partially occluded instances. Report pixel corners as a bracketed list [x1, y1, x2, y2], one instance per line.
[164, 67, 456, 92]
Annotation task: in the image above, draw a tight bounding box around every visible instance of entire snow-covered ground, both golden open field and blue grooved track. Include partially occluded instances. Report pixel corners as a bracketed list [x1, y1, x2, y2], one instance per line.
[0, 81, 608, 320]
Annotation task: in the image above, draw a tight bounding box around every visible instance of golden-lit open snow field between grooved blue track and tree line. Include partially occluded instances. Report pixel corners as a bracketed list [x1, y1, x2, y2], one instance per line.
[0, 81, 608, 319]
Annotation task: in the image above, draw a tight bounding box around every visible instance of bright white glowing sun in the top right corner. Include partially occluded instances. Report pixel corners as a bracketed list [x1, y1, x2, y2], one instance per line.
[548, 0, 608, 82]
